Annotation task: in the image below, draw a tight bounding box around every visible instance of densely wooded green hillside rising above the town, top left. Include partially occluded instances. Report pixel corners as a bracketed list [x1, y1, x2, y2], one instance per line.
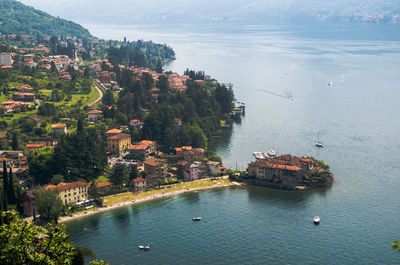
[0, 0, 92, 38]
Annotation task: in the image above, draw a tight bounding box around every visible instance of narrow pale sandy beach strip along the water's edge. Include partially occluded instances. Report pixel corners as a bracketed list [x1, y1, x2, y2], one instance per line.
[58, 177, 243, 223]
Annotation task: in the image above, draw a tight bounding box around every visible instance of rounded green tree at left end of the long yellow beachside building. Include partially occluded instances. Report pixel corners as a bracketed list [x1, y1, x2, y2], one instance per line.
[36, 189, 64, 223]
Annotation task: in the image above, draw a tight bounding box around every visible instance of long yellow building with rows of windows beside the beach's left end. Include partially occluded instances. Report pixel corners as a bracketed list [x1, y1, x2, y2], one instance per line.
[45, 181, 88, 204]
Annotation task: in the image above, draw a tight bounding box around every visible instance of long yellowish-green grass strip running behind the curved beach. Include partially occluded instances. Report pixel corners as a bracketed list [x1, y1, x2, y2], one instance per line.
[103, 179, 232, 206]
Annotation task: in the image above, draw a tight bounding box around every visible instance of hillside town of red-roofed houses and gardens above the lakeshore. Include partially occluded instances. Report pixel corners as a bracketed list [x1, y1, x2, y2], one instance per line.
[0, 31, 237, 221]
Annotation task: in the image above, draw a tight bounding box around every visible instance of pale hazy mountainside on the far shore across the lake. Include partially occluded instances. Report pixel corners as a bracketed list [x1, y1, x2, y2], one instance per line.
[18, 0, 400, 24]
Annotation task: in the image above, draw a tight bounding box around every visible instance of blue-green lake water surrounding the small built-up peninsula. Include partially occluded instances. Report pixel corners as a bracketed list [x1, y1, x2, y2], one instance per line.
[69, 22, 400, 264]
